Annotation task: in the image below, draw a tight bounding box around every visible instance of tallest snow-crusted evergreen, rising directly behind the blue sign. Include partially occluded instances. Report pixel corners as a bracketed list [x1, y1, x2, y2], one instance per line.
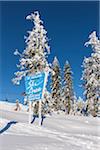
[12, 11, 50, 114]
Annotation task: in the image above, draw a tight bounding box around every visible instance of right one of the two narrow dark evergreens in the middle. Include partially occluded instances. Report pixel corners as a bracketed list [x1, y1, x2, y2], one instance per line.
[63, 61, 74, 114]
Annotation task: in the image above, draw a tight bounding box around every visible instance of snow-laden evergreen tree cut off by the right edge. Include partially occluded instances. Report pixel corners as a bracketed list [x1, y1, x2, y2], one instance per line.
[82, 31, 100, 116]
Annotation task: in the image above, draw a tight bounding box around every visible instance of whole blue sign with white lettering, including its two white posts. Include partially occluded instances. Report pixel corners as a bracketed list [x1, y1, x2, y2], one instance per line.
[25, 72, 48, 126]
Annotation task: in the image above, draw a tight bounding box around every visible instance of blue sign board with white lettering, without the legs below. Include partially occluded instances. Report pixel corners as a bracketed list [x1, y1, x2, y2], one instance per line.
[25, 72, 45, 101]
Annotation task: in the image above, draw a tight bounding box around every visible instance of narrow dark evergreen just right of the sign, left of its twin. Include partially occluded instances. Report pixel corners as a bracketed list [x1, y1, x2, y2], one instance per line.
[51, 57, 62, 111]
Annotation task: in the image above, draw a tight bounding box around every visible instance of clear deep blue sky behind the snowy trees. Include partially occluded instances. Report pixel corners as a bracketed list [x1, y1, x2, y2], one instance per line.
[0, 1, 99, 103]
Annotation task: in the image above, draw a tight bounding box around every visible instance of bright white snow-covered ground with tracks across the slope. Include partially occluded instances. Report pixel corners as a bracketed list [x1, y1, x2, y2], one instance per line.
[0, 102, 100, 150]
